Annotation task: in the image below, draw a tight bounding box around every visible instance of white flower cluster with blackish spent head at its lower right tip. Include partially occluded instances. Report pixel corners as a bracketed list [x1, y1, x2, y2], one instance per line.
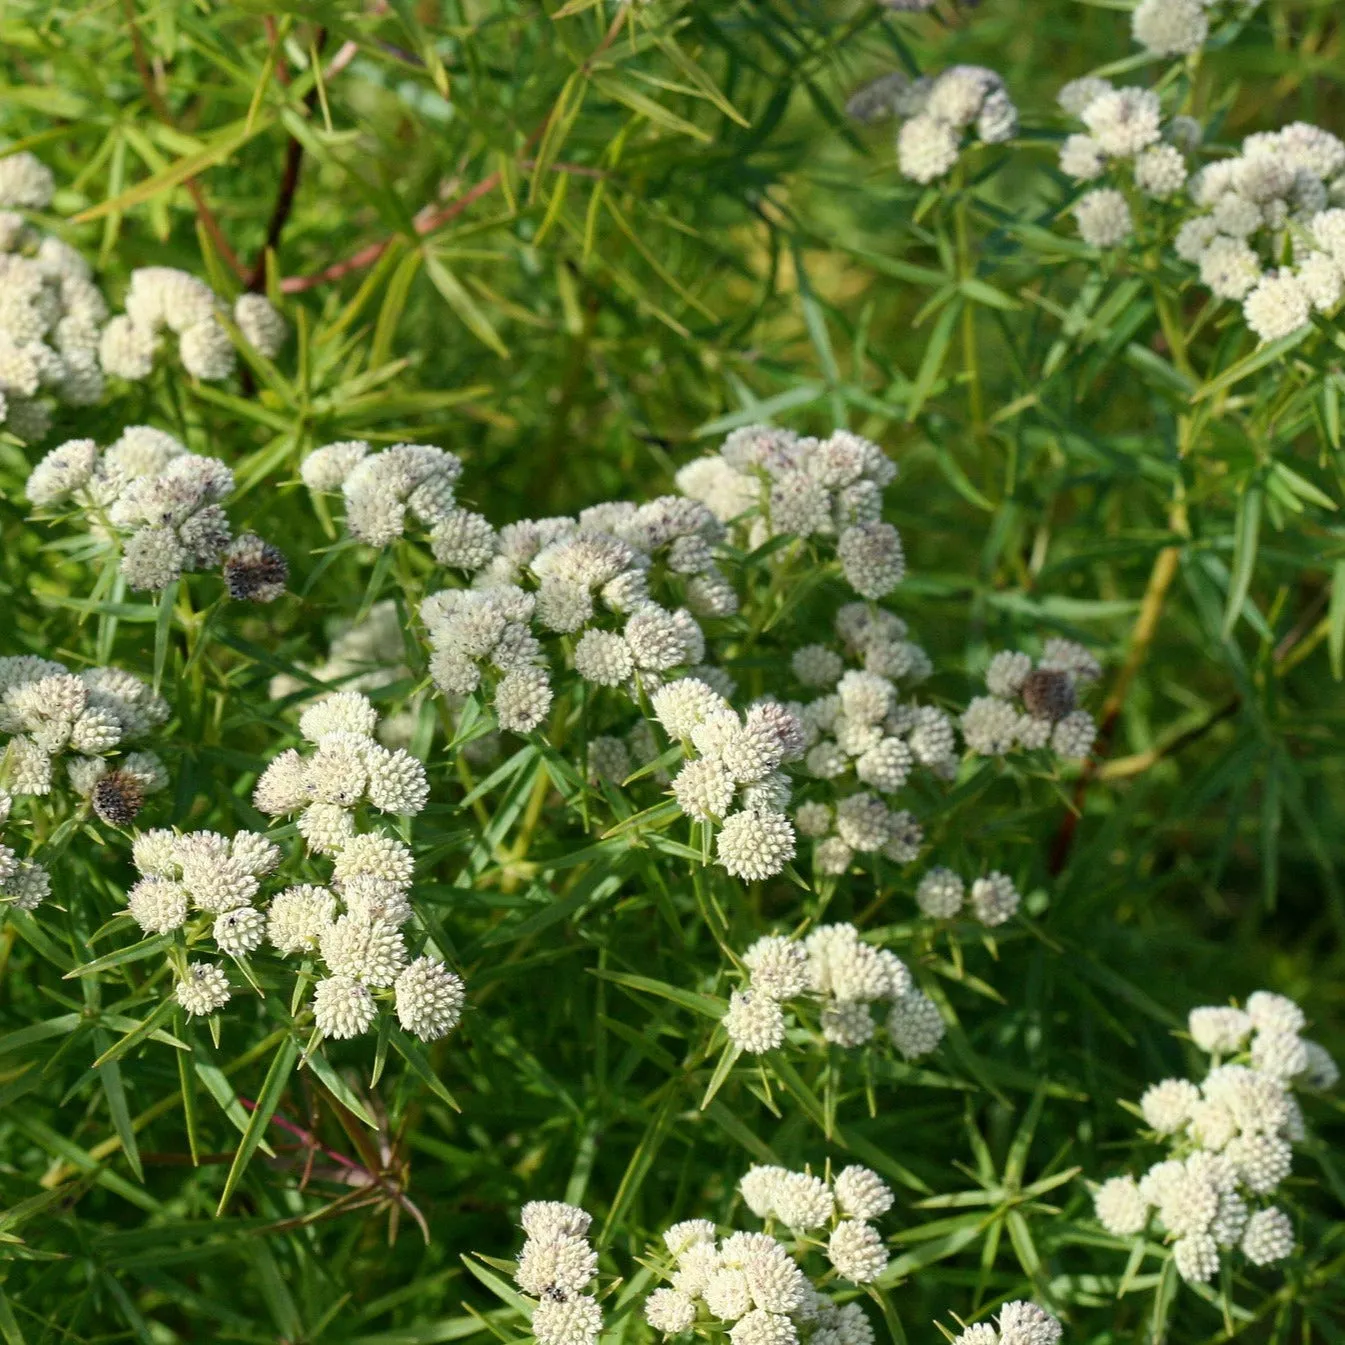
[27, 425, 270, 597]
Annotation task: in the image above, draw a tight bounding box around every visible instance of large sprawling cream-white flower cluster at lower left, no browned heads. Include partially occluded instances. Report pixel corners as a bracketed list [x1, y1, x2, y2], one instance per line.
[126, 691, 464, 1041]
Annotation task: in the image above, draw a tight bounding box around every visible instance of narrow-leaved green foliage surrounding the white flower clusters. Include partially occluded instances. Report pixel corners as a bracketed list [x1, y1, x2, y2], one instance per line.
[0, 0, 1345, 1345]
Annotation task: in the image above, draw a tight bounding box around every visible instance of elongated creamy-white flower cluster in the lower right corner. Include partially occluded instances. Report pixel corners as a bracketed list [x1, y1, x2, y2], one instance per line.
[1093, 990, 1340, 1284]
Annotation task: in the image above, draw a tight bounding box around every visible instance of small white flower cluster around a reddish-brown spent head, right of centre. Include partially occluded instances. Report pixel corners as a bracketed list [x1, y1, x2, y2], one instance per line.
[960, 639, 1102, 759]
